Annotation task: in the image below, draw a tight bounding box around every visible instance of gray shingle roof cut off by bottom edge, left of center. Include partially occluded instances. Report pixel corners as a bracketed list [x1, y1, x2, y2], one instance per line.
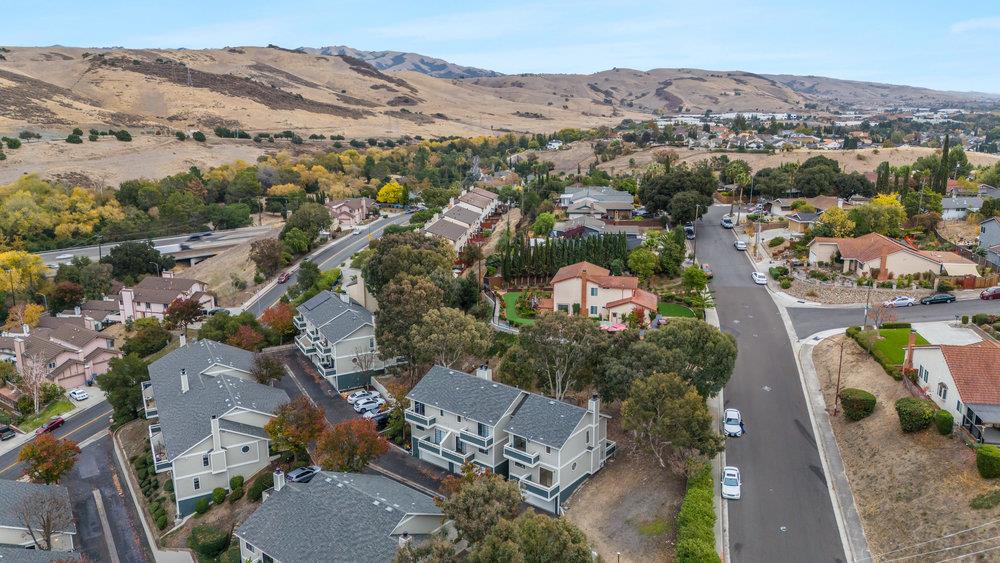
[236, 472, 443, 563]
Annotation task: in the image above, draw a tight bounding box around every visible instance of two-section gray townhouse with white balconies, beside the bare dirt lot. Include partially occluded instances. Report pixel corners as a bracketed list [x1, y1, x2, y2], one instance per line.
[404, 366, 617, 514]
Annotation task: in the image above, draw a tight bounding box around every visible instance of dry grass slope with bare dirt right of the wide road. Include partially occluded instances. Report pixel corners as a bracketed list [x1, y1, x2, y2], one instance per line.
[813, 335, 1000, 562]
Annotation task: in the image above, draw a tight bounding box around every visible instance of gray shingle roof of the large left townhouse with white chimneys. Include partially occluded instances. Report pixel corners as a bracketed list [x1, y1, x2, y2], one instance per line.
[149, 340, 288, 459]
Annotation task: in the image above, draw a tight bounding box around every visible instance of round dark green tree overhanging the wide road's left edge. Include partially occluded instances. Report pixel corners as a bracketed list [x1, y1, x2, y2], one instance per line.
[646, 319, 736, 397]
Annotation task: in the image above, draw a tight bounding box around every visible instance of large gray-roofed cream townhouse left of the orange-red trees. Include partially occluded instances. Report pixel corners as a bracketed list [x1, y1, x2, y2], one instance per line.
[141, 340, 288, 517]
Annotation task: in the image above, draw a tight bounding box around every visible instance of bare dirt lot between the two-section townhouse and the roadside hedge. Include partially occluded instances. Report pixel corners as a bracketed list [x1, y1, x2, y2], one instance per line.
[565, 412, 684, 562]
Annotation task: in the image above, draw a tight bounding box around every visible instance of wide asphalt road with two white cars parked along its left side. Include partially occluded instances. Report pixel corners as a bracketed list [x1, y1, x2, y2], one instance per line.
[697, 207, 846, 562]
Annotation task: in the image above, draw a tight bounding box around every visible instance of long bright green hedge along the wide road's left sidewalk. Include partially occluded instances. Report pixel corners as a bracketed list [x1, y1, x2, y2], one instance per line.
[677, 464, 719, 563]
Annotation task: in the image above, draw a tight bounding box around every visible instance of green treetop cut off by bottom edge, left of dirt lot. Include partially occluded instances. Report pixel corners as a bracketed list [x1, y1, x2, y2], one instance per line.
[469, 512, 594, 563]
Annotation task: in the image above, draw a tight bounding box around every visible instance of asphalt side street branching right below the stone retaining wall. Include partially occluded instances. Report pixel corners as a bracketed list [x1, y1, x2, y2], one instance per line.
[788, 299, 1000, 338]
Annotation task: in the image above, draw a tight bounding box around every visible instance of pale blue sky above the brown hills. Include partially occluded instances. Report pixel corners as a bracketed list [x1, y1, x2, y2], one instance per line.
[0, 0, 1000, 93]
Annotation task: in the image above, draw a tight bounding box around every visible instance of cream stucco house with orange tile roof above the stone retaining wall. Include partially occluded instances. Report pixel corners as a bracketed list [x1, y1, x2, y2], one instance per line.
[809, 233, 979, 280]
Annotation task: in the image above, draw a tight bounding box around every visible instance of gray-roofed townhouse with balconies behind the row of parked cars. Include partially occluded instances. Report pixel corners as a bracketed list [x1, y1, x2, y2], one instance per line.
[294, 291, 386, 391]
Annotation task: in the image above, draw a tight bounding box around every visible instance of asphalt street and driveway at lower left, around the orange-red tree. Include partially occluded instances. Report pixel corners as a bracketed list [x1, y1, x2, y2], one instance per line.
[0, 401, 153, 561]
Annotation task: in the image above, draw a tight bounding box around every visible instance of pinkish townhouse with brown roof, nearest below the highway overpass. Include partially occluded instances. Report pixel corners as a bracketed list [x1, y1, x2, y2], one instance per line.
[118, 271, 215, 322]
